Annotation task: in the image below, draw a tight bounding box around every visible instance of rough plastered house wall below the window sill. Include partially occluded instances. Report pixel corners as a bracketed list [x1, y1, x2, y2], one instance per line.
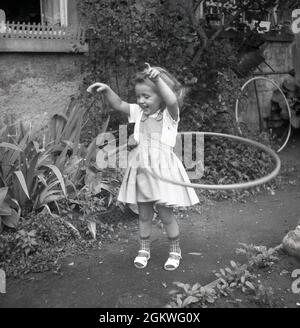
[0, 53, 86, 129]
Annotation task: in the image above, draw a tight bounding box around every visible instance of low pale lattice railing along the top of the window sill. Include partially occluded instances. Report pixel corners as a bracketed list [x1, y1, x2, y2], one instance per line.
[0, 22, 85, 44]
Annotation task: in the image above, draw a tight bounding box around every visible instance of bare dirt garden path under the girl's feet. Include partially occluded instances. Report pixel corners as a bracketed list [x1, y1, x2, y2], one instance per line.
[0, 131, 300, 308]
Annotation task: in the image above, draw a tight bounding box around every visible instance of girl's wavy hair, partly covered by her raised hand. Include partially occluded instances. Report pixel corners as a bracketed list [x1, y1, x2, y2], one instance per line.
[134, 66, 187, 106]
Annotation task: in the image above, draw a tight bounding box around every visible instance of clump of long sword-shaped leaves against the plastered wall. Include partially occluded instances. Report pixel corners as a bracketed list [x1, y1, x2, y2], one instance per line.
[0, 93, 116, 229]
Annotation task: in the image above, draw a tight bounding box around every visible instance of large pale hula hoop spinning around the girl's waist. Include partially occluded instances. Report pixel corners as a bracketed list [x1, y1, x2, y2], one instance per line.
[148, 132, 281, 190]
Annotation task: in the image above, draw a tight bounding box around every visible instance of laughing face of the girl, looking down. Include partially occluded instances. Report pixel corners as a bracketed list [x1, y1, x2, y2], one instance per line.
[135, 83, 162, 115]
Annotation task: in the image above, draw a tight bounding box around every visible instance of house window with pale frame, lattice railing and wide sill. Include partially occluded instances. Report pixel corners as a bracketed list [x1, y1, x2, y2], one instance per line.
[0, 0, 87, 52]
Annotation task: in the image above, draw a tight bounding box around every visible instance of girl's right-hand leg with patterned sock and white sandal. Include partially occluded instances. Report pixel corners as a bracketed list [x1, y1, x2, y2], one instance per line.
[157, 205, 181, 270]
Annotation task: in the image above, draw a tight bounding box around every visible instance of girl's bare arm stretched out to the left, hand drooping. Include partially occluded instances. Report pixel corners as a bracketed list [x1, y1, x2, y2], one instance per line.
[86, 82, 130, 115]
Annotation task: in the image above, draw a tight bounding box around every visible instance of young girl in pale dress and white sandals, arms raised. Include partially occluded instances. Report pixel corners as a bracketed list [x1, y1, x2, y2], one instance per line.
[87, 66, 199, 271]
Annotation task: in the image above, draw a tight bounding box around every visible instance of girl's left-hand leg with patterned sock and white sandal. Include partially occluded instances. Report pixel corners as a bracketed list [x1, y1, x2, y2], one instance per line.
[134, 202, 154, 269]
